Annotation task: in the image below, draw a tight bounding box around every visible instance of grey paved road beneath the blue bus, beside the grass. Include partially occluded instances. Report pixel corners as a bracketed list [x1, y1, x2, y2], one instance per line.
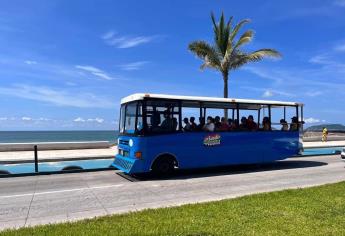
[0, 156, 345, 229]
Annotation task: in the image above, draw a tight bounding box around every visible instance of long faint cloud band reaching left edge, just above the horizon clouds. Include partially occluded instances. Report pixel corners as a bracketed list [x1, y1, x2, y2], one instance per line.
[0, 84, 114, 108]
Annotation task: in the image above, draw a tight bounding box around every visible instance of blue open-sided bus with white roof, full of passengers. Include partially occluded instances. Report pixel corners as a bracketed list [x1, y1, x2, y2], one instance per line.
[112, 94, 303, 174]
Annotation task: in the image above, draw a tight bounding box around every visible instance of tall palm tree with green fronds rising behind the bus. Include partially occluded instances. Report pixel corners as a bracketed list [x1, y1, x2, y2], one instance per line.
[188, 12, 281, 118]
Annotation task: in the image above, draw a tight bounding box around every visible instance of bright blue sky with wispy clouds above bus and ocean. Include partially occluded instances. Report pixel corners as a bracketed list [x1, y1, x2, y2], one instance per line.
[0, 0, 345, 130]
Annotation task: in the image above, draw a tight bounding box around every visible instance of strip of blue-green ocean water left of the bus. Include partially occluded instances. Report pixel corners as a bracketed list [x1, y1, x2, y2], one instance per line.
[0, 131, 118, 143]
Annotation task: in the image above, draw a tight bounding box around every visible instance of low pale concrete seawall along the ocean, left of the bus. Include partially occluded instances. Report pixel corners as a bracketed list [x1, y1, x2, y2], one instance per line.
[0, 141, 111, 152]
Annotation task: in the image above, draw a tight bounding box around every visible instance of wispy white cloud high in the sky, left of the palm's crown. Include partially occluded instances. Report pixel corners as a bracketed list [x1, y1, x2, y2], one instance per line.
[102, 31, 158, 48]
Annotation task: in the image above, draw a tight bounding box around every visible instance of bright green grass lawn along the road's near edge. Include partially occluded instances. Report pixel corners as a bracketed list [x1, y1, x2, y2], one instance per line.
[0, 182, 345, 235]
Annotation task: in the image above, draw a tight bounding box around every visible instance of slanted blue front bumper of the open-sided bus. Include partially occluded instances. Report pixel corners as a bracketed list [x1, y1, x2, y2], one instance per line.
[112, 154, 143, 174]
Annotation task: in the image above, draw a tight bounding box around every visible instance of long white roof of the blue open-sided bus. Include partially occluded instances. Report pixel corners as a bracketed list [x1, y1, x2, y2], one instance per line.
[121, 93, 303, 106]
